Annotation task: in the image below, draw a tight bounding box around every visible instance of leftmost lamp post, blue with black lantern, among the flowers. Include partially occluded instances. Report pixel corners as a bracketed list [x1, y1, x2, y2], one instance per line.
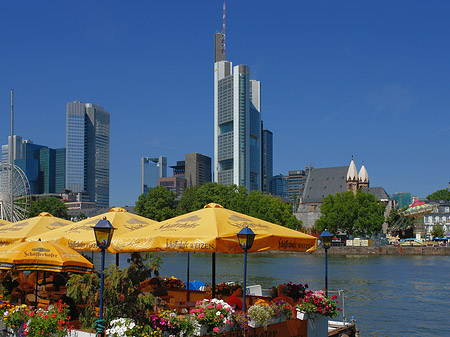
[92, 217, 115, 335]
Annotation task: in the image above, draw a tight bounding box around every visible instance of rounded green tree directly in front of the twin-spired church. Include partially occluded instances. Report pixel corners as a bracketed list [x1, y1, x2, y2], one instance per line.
[315, 190, 386, 236]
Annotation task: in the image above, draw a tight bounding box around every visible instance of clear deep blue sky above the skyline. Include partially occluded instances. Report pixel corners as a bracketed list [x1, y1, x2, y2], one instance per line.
[0, 0, 450, 206]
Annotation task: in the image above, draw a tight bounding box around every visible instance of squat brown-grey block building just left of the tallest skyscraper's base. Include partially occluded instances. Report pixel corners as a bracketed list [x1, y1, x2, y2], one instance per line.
[184, 153, 211, 187]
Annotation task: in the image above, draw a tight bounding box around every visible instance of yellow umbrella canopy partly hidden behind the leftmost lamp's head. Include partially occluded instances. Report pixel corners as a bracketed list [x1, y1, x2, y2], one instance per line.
[27, 207, 158, 251]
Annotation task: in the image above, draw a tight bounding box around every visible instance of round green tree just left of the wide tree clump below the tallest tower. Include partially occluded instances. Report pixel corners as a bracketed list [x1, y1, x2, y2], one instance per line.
[135, 186, 176, 221]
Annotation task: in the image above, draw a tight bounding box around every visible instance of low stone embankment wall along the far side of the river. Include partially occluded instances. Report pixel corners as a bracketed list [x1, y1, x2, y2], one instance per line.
[315, 246, 450, 256]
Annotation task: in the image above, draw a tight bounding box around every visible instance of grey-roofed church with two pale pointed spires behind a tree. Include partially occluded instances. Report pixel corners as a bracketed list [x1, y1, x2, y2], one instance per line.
[295, 156, 392, 228]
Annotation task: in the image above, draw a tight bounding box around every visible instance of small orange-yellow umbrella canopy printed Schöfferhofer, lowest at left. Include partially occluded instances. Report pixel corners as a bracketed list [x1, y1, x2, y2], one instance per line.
[0, 241, 93, 273]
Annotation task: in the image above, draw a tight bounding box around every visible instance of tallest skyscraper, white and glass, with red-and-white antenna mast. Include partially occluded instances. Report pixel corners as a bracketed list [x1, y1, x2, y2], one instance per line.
[214, 3, 261, 191]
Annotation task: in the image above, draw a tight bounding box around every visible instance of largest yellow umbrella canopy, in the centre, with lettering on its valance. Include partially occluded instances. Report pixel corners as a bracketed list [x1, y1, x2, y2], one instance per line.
[108, 204, 317, 253]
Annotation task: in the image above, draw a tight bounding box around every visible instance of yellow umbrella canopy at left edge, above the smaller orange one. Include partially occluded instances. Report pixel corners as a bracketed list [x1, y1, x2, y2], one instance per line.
[0, 212, 73, 245]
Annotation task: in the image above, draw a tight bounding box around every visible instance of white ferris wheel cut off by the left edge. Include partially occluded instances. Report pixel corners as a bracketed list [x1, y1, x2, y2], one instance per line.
[0, 164, 31, 222]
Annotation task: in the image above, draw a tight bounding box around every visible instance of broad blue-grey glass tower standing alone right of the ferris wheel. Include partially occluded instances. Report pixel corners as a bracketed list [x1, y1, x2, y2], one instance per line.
[66, 101, 110, 207]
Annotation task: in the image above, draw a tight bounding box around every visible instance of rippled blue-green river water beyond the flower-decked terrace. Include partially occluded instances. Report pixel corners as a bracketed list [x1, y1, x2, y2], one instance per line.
[95, 252, 450, 337]
